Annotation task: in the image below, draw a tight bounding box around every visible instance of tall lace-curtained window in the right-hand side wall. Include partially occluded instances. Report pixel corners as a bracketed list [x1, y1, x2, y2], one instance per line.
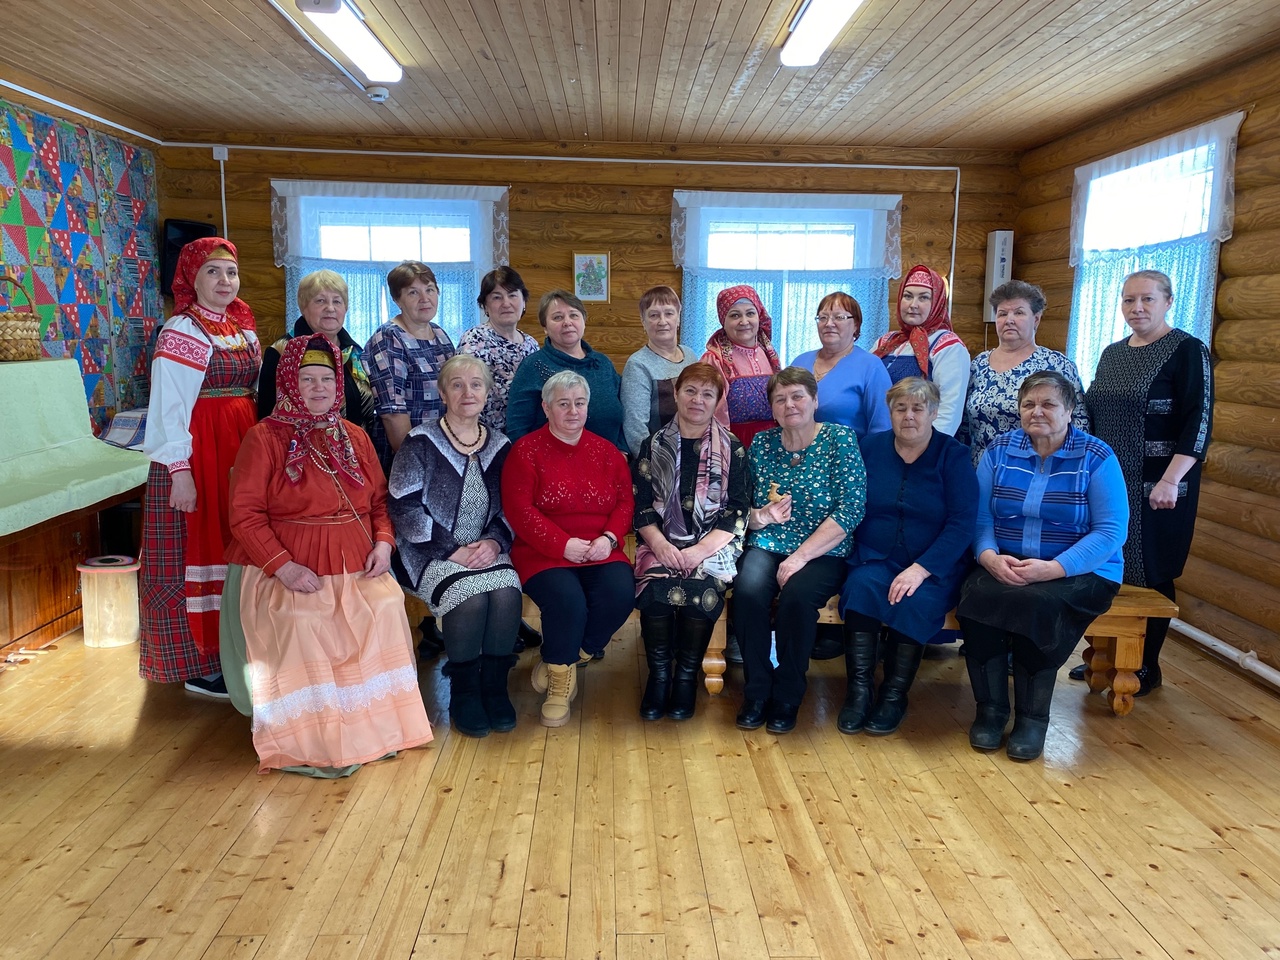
[1068, 113, 1244, 385]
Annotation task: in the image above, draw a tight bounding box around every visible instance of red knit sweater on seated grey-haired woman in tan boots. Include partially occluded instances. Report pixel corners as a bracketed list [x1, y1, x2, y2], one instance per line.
[502, 426, 635, 582]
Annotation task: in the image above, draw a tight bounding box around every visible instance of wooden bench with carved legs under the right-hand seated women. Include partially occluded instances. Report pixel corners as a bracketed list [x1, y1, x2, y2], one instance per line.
[703, 584, 1178, 717]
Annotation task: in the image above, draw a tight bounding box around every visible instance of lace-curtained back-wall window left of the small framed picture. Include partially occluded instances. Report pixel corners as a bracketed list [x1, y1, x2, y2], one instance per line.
[271, 180, 507, 343]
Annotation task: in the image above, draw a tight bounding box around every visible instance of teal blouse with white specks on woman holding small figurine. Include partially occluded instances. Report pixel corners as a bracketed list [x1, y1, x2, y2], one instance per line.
[746, 424, 867, 557]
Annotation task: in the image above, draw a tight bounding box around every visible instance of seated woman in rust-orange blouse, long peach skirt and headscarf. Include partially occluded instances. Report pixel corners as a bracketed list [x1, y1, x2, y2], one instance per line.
[221, 334, 431, 777]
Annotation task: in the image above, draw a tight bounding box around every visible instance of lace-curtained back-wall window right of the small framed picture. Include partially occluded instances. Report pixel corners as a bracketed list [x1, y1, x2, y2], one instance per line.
[671, 191, 901, 361]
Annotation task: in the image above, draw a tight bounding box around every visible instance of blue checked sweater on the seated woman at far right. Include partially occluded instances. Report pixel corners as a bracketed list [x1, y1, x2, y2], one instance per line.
[974, 426, 1129, 584]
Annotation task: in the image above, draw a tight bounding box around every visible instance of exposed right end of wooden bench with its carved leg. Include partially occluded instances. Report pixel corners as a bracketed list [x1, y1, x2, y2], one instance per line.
[1082, 584, 1178, 717]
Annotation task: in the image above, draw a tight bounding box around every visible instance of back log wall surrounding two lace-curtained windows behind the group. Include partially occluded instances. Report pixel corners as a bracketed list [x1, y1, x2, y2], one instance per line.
[159, 142, 1018, 369]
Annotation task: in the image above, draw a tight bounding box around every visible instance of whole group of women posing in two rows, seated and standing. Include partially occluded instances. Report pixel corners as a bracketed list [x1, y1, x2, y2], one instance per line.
[142, 238, 1211, 777]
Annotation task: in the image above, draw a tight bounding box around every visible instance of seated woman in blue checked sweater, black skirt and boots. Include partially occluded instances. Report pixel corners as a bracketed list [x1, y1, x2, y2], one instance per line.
[957, 370, 1129, 760]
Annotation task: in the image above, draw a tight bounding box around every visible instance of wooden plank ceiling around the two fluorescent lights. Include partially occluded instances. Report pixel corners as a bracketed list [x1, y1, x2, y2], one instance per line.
[0, 0, 1280, 150]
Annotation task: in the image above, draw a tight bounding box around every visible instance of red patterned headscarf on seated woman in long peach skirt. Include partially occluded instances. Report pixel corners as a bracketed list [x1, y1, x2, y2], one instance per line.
[268, 333, 365, 486]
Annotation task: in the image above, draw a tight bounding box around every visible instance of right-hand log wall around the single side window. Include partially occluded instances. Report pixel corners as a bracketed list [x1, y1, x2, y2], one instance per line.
[1014, 54, 1280, 667]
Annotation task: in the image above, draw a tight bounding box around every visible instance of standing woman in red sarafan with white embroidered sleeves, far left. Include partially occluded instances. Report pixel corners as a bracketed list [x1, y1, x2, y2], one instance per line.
[140, 237, 262, 699]
